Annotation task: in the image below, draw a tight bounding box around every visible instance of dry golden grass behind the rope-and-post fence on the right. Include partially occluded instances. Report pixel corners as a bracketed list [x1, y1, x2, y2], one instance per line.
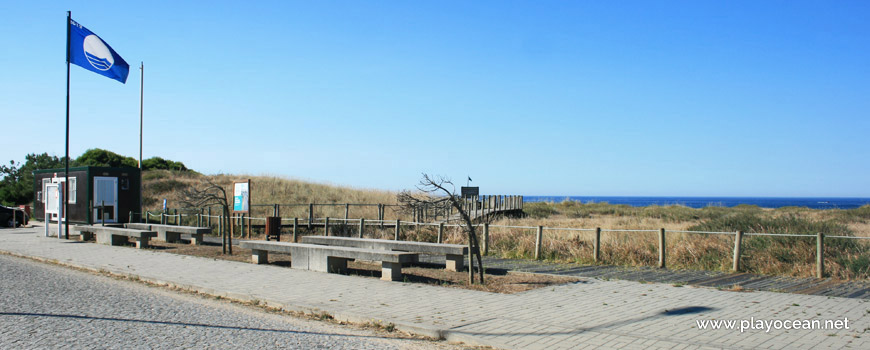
[490, 202, 870, 279]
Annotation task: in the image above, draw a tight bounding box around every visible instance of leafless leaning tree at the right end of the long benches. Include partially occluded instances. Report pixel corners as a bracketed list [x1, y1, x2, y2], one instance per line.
[398, 173, 484, 284]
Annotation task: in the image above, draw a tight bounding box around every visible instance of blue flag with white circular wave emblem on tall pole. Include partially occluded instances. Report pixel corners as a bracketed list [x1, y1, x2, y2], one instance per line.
[68, 19, 130, 83]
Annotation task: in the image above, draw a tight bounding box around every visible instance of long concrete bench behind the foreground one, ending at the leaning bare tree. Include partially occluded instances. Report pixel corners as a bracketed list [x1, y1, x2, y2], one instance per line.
[302, 236, 476, 271]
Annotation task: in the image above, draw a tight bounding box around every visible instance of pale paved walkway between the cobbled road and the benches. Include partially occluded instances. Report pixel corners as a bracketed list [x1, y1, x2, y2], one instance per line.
[0, 228, 870, 349]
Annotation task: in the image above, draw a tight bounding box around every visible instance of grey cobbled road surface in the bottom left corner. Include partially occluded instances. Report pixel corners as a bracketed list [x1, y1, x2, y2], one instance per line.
[0, 255, 457, 349]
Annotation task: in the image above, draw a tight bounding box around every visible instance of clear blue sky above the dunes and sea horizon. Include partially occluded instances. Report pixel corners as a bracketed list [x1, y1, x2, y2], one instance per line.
[0, 1, 870, 197]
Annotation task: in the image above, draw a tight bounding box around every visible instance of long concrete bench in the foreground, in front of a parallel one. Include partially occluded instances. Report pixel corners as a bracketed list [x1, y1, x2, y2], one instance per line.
[239, 241, 417, 281]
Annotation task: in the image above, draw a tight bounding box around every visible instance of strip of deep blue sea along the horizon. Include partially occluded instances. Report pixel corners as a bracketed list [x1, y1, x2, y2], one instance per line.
[523, 196, 870, 209]
